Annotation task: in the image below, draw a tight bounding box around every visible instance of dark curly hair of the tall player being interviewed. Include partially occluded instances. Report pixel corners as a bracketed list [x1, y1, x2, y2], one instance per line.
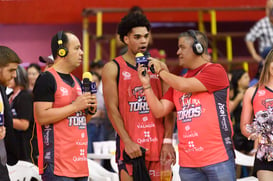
[118, 13, 151, 43]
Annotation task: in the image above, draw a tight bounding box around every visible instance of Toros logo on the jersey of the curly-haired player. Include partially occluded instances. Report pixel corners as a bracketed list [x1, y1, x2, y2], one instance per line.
[129, 86, 150, 114]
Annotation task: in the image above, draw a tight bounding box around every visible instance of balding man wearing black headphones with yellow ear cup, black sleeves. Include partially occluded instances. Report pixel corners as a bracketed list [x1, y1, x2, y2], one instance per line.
[33, 31, 96, 181]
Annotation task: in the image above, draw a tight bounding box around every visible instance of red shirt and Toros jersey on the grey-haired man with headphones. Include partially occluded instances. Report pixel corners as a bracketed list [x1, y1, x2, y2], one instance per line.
[163, 63, 233, 167]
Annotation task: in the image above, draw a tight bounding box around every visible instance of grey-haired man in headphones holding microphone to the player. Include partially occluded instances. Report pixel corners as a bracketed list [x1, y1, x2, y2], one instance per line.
[138, 30, 236, 181]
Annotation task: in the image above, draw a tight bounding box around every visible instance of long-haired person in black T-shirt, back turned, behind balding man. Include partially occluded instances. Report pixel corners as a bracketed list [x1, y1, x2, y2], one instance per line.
[9, 65, 38, 164]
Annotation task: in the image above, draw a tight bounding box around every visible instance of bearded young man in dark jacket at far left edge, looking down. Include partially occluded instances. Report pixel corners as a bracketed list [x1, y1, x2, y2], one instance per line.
[0, 46, 21, 181]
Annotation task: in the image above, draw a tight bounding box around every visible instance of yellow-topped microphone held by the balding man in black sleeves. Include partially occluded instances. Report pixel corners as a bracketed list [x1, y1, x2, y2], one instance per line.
[82, 72, 97, 115]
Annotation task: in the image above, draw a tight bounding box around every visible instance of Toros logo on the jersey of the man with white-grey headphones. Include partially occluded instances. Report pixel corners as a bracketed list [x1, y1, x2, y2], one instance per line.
[177, 93, 202, 123]
